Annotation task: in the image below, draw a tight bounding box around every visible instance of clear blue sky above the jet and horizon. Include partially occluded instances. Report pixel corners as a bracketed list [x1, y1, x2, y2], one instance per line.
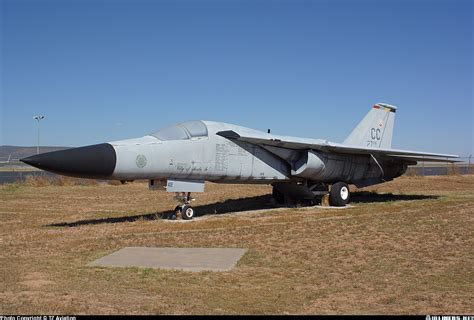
[0, 0, 474, 155]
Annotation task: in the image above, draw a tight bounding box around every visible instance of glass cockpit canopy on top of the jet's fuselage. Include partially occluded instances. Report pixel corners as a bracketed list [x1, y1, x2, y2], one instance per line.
[151, 121, 208, 141]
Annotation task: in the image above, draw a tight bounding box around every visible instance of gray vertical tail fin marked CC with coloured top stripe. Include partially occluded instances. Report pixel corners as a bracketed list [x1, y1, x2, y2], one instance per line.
[344, 103, 397, 149]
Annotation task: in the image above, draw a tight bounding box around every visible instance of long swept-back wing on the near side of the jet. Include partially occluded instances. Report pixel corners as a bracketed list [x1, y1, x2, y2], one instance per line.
[217, 130, 459, 162]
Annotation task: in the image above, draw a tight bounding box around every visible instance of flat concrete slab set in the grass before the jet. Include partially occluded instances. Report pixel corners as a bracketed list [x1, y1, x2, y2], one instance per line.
[88, 247, 247, 271]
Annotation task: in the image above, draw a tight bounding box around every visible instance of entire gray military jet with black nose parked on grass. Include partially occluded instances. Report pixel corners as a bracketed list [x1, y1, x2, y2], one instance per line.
[21, 103, 458, 219]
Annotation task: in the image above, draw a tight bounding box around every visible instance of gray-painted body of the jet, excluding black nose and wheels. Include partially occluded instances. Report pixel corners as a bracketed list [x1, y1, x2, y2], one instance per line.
[105, 103, 456, 192]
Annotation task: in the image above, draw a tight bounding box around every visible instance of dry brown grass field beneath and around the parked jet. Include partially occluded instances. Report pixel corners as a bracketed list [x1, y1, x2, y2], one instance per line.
[0, 175, 474, 314]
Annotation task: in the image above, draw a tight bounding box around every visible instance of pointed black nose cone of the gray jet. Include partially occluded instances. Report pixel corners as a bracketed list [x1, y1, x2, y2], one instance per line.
[20, 143, 117, 179]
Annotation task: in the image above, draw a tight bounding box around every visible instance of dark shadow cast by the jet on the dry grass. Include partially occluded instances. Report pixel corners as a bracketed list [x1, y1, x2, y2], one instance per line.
[45, 191, 438, 227]
